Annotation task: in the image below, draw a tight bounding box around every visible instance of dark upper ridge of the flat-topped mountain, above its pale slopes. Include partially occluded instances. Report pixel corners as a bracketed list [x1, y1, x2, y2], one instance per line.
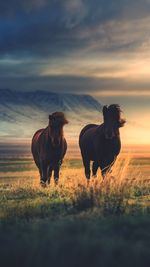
[0, 89, 101, 111]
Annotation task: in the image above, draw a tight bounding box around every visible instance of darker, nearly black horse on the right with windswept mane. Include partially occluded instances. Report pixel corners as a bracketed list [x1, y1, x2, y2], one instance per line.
[79, 104, 125, 180]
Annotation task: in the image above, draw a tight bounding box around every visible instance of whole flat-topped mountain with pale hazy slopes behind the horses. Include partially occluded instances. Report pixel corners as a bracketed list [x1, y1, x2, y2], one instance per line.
[0, 89, 102, 138]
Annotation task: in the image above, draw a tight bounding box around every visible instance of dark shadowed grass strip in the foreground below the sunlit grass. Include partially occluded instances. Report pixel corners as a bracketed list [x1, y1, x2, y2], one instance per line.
[0, 213, 150, 267]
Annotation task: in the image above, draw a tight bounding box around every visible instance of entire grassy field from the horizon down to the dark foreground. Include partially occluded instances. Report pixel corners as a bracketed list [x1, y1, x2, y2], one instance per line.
[0, 157, 150, 267]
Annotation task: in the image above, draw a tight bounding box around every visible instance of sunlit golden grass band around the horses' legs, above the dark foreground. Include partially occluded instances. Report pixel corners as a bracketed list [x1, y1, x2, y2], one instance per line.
[0, 156, 150, 221]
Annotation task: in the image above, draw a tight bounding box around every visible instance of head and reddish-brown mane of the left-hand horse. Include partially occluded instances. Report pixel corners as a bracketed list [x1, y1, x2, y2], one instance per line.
[48, 112, 68, 147]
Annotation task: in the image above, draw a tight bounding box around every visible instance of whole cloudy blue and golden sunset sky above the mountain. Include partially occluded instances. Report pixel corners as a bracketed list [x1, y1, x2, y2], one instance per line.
[0, 0, 150, 146]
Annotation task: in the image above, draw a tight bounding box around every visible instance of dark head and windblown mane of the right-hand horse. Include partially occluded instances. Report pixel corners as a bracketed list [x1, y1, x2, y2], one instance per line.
[103, 104, 126, 139]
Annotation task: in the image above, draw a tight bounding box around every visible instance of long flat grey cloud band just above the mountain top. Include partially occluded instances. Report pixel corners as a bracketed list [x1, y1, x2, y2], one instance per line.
[0, 73, 149, 94]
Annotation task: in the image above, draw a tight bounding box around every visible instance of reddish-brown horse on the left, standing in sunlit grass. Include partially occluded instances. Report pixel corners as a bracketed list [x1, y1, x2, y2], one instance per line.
[31, 112, 68, 185]
